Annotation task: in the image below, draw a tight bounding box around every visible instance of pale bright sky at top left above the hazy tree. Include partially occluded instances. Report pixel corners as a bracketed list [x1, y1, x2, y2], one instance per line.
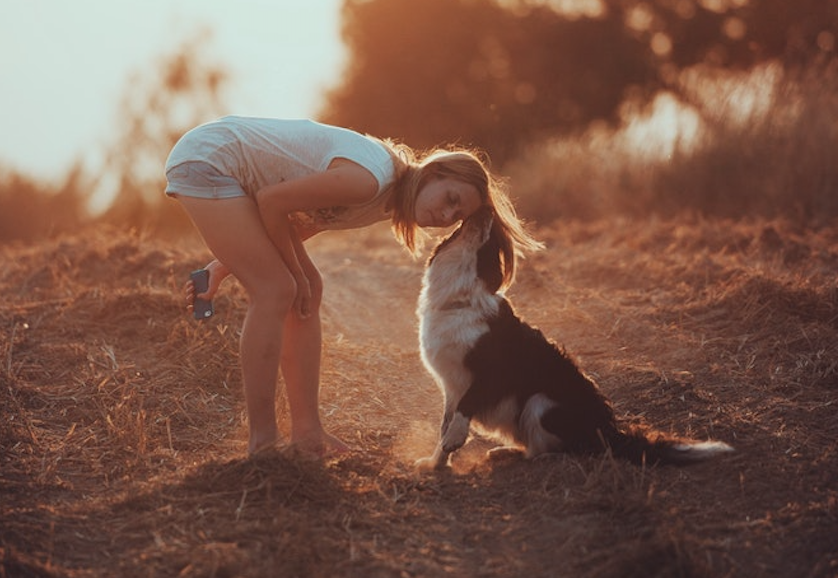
[0, 0, 344, 179]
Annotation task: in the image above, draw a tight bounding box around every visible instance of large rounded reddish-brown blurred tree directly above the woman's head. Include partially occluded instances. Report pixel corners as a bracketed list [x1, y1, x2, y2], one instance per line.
[322, 0, 654, 160]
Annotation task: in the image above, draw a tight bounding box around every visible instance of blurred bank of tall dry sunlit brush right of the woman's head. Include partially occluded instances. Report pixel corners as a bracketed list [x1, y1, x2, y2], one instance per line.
[506, 63, 838, 225]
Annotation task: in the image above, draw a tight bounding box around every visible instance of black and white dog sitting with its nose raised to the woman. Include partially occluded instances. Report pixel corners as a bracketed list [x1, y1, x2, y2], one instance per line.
[417, 209, 733, 468]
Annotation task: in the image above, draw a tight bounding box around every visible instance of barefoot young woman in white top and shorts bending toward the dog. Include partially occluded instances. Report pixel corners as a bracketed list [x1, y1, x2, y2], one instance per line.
[166, 117, 539, 454]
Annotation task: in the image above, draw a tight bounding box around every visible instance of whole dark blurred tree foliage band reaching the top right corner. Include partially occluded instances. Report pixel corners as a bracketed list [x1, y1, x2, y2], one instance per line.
[321, 0, 838, 162]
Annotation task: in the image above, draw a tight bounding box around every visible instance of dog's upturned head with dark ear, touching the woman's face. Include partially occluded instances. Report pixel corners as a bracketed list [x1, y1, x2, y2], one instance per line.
[428, 206, 506, 294]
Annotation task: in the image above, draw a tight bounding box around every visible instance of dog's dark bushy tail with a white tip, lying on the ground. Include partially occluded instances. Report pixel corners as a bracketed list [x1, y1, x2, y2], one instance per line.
[605, 428, 733, 466]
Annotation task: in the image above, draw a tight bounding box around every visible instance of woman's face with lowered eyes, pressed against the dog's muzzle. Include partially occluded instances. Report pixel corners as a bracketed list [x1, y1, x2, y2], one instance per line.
[413, 178, 483, 227]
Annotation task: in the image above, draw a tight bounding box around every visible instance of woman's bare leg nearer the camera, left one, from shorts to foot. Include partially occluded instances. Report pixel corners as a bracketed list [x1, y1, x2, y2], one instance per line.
[179, 197, 296, 453]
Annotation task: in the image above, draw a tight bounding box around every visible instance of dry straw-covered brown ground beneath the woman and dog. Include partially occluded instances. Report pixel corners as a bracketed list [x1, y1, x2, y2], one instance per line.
[0, 221, 838, 577]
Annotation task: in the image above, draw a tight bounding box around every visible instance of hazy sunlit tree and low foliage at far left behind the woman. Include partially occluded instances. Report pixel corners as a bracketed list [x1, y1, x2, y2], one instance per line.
[0, 34, 228, 242]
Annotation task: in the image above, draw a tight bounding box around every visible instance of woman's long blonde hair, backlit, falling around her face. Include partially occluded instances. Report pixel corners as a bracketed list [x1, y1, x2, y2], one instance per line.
[376, 141, 544, 287]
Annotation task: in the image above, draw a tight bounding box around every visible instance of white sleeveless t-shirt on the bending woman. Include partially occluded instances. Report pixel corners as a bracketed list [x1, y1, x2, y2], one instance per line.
[166, 116, 394, 229]
